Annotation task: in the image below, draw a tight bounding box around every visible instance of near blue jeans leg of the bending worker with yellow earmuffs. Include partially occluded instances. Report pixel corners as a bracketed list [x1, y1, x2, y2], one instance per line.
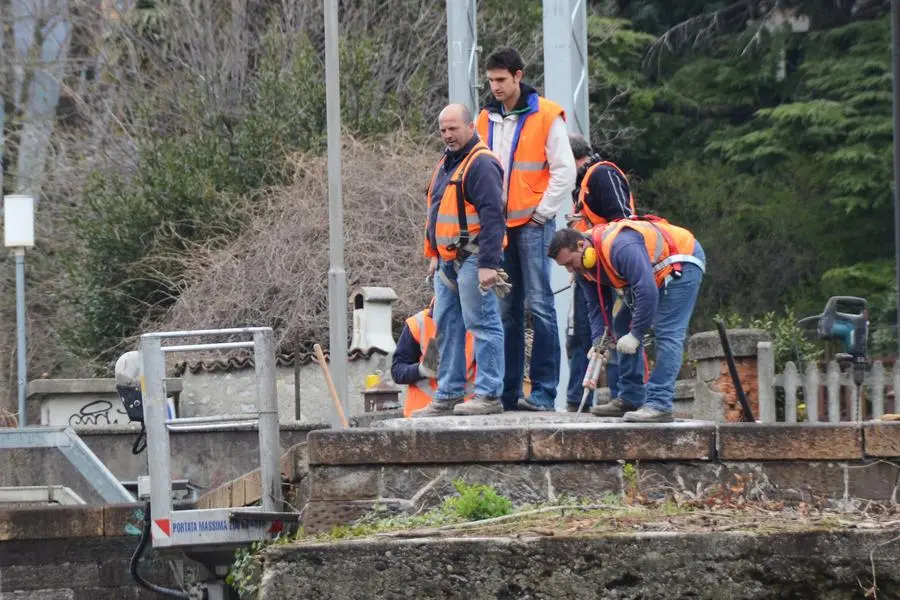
[643, 242, 706, 412]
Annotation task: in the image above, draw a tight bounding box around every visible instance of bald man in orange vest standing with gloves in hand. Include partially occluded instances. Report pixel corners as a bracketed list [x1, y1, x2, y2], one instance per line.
[412, 104, 508, 417]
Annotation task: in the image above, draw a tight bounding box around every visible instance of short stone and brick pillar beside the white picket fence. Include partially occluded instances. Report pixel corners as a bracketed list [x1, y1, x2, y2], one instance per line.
[688, 329, 769, 422]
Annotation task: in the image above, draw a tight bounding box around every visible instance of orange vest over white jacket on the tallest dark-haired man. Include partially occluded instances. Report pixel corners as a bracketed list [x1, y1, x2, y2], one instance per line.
[476, 96, 566, 227]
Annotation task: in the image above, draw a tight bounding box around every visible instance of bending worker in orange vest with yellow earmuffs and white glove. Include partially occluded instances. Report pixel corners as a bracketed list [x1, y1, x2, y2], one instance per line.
[548, 219, 706, 423]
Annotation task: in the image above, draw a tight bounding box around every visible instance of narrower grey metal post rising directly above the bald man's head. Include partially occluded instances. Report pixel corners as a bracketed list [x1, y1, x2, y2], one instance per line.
[447, 0, 479, 115]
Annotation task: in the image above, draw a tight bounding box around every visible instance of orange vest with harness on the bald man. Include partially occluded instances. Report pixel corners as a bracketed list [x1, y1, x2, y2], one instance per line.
[425, 141, 506, 261]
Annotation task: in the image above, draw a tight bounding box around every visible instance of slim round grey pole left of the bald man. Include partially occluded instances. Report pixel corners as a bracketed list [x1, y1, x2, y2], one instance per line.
[323, 0, 349, 427]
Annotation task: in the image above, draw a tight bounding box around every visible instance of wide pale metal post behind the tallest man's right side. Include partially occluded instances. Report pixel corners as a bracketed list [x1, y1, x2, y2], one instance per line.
[543, 0, 590, 405]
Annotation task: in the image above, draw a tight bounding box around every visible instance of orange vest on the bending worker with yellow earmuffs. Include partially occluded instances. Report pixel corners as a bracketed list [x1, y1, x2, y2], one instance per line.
[591, 219, 703, 289]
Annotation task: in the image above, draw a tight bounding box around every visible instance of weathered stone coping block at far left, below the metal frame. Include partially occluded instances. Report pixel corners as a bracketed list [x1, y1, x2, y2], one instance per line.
[0, 506, 103, 541]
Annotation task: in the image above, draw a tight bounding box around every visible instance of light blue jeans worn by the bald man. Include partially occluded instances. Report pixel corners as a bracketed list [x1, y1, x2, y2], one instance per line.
[434, 255, 503, 401]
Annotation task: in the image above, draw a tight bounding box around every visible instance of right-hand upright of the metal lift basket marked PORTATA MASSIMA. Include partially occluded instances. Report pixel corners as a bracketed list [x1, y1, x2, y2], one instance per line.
[253, 329, 283, 512]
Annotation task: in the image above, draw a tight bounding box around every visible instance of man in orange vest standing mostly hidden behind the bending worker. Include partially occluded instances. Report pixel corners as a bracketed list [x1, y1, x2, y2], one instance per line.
[566, 133, 644, 412]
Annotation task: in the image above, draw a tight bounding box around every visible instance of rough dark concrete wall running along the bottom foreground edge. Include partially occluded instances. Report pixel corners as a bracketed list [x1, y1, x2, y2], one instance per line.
[261, 531, 900, 600]
